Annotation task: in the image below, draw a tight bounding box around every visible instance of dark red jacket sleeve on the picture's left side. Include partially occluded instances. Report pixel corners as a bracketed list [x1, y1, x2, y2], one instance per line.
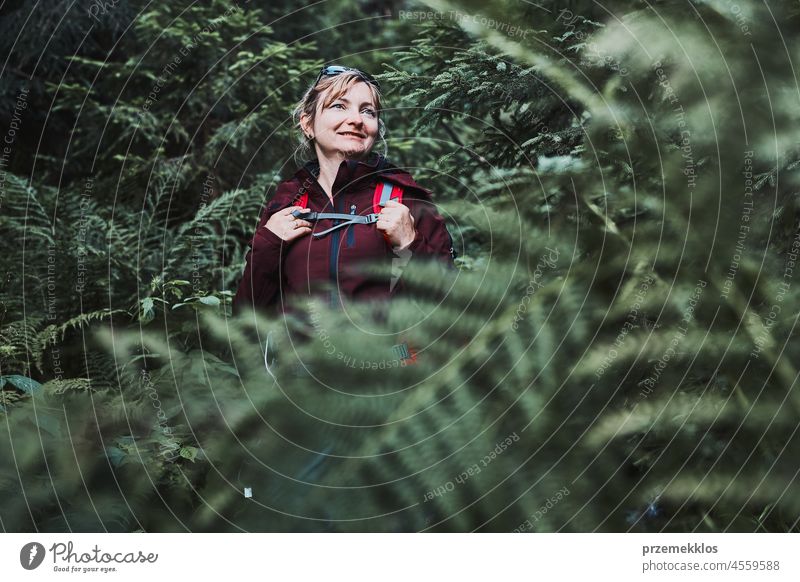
[233, 194, 287, 315]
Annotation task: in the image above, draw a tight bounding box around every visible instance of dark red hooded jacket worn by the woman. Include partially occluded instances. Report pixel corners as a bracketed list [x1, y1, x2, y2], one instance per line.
[233, 155, 455, 312]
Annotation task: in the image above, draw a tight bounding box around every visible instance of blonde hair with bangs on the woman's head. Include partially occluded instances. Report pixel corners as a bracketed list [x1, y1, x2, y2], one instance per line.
[292, 71, 386, 161]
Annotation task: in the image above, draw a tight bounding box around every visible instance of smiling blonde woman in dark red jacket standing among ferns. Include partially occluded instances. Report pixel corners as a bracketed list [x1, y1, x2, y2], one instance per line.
[233, 66, 455, 318]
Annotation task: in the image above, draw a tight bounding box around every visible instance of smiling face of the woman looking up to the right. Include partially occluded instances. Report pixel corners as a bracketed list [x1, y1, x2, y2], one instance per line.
[306, 82, 378, 159]
